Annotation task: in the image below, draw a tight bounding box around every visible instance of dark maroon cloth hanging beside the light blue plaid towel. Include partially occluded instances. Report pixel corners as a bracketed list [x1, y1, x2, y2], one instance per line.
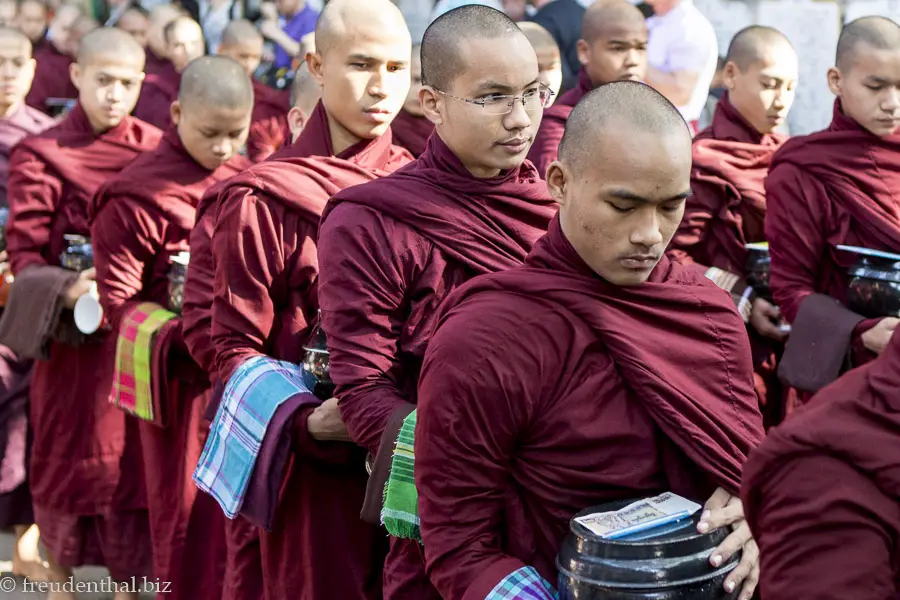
[241, 393, 322, 531]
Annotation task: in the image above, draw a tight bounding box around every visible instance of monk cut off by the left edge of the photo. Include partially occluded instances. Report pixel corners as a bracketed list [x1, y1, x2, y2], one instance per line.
[0, 28, 53, 579]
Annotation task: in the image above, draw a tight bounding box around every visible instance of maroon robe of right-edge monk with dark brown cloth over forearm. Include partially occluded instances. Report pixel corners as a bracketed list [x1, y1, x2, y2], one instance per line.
[765, 101, 900, 364]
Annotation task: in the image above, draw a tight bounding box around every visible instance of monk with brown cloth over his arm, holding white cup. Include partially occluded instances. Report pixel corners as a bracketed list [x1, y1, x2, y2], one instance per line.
[7, 29, 160, 600]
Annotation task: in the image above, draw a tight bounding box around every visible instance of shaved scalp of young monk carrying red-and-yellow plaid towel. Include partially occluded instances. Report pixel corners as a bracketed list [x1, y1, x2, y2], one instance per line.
[178, 56, 253, 110]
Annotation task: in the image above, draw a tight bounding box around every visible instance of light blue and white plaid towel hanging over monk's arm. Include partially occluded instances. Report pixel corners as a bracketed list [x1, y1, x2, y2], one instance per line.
[193, 356, 309, 519]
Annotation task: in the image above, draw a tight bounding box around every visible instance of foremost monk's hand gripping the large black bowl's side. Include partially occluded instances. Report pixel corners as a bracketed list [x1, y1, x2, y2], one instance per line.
[697, 488, 759, 600]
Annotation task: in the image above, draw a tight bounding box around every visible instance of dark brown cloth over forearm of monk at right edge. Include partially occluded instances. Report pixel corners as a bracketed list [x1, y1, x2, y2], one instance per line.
[778, 294, 864, 392]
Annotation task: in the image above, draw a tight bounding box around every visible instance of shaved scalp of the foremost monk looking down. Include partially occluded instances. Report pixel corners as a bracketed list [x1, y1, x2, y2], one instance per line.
[559, 81, 691, 169]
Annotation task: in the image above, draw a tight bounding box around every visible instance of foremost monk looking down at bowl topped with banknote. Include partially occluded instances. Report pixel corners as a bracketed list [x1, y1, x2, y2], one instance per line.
[415, 82, 763, 600]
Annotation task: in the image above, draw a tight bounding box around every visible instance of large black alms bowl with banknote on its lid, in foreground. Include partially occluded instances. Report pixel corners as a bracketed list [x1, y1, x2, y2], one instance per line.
[556, 500, 740, 600]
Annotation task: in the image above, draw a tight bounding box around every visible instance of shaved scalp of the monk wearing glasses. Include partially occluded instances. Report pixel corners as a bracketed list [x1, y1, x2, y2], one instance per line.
[422, 4, 530, 90]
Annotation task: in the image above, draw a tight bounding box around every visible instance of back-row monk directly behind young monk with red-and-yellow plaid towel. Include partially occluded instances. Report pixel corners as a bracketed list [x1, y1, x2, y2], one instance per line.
[134, 16, 206, 129]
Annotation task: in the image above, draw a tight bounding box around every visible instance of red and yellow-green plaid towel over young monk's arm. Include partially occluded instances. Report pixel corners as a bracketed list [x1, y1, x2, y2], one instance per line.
[109, 302, 177, 424]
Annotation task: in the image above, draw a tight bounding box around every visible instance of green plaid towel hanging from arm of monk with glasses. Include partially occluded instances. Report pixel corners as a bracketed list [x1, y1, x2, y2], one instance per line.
[381, 411, 422, 542]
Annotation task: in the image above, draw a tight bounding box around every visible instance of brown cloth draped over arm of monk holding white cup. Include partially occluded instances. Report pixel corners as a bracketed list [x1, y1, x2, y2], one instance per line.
[0, 266, 84, 360]
